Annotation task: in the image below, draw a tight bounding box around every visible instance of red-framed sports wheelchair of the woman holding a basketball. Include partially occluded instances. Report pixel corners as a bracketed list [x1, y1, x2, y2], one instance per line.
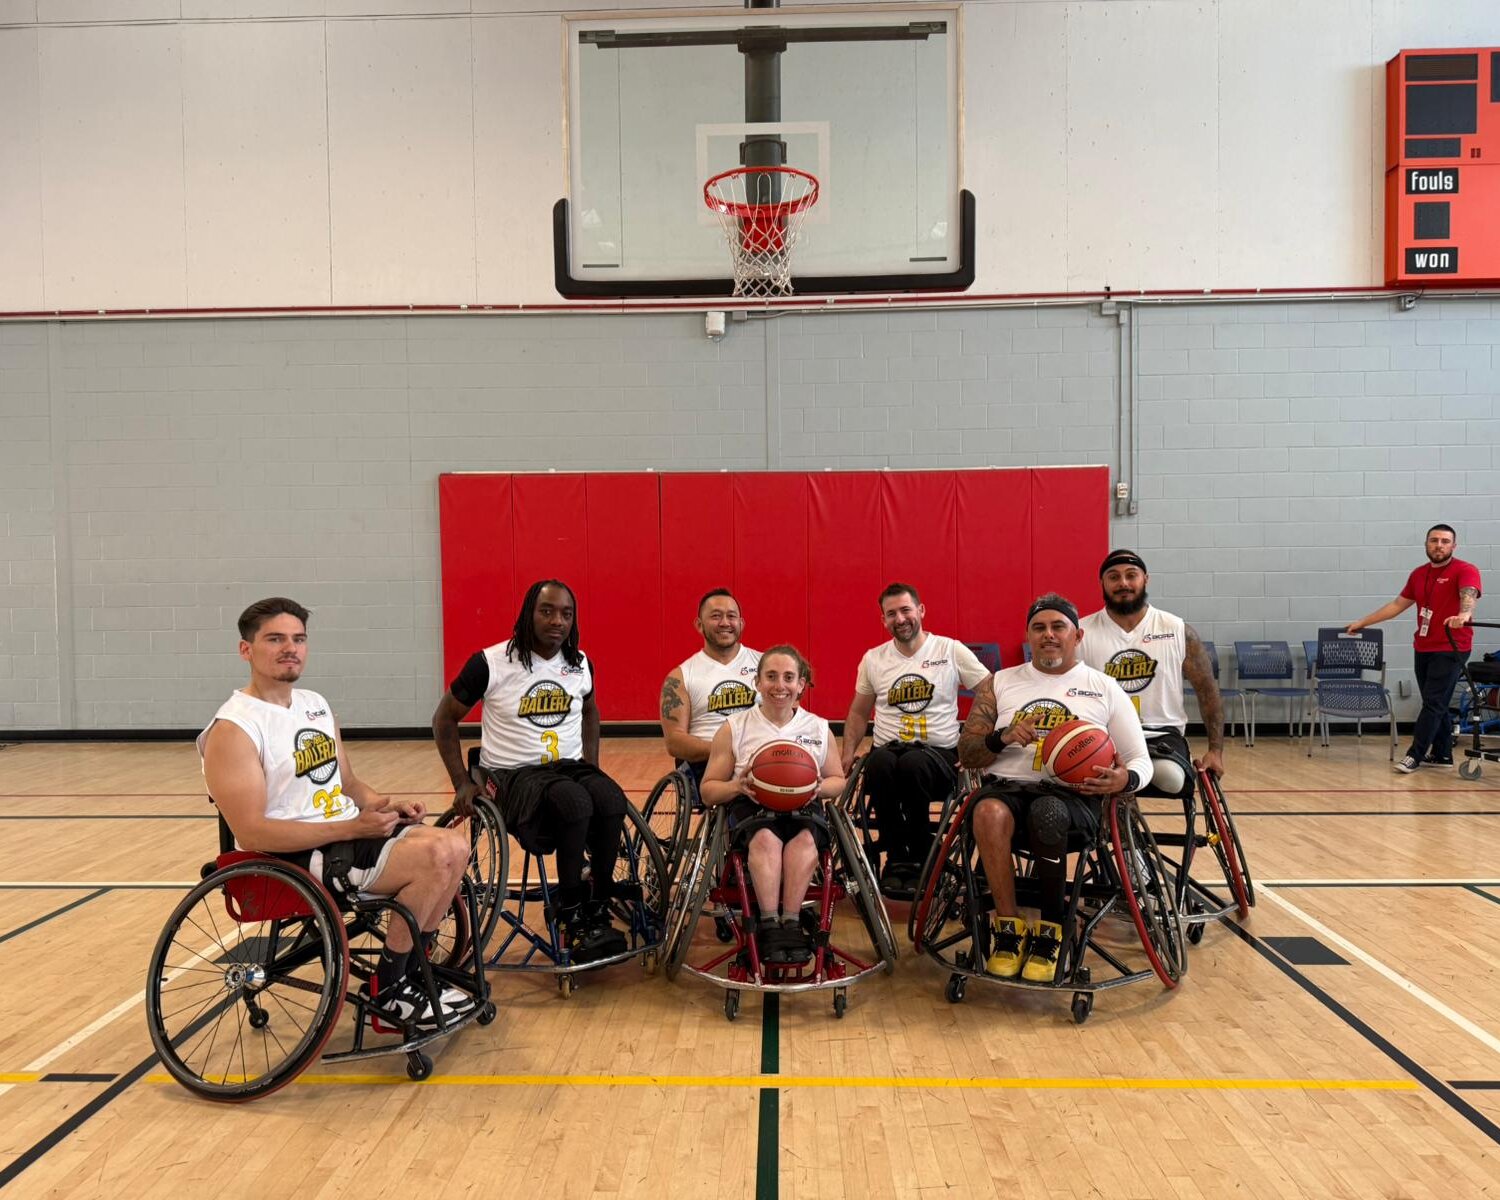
[666, 791, 897, 1020]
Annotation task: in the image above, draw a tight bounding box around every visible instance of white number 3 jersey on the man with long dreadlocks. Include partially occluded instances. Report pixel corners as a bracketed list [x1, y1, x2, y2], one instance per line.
[479, 642, 594, 770]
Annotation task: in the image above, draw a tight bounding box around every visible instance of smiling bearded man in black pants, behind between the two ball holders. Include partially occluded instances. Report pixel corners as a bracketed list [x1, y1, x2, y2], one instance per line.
[843, 584, 990, 900]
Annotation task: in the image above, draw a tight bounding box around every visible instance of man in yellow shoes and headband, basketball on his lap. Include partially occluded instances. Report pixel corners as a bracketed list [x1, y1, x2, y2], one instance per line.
[959, 593, 1151, 984]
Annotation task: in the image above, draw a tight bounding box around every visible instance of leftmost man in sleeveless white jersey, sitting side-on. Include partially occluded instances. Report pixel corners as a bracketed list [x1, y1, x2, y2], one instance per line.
[198, 596, 470, 1034]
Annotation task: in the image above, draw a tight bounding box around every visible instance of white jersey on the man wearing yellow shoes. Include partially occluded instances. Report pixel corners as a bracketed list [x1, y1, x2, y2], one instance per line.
[984, 663, 1152, 783]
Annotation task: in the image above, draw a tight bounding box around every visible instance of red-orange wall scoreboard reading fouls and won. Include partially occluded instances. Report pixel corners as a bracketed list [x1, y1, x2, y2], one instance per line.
[1386, 48, 1500, 287]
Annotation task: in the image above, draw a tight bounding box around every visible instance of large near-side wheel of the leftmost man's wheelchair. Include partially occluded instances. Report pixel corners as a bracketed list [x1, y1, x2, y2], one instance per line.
[146, 860, 350, 1101]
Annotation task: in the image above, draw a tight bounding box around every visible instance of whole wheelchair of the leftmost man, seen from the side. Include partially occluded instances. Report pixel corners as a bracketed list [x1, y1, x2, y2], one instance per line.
[146, 816, 495, 1101]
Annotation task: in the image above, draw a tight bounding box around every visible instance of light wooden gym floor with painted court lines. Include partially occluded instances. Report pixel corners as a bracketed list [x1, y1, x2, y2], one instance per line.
[0, 737, 1500, 1200]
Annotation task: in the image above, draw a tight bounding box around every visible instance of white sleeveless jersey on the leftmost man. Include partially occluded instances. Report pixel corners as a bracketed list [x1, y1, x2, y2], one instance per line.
[198, 687, 360, 845]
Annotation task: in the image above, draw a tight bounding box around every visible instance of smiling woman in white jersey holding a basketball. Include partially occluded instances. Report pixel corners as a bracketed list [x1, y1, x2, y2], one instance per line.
[701, 645, 845, 963]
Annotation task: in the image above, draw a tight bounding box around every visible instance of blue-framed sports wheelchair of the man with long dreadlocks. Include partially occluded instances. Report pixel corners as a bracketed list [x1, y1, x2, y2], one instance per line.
[438, 747, 669, 998]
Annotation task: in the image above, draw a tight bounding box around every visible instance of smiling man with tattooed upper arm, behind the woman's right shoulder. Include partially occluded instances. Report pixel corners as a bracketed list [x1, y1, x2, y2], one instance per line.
[662, 588, 761, 783]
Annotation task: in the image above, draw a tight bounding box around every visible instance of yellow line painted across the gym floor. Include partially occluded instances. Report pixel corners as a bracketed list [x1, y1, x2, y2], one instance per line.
[146, 1074, 1421, 1092]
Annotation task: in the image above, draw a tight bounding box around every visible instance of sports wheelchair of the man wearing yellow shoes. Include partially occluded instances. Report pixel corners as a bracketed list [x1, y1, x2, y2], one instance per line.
[911, 789, 1188, 1025]
